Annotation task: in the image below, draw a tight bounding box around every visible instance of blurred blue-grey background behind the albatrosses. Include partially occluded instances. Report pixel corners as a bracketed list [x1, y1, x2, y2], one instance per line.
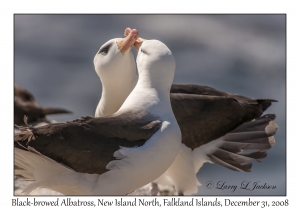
[11, 15, 286, 195]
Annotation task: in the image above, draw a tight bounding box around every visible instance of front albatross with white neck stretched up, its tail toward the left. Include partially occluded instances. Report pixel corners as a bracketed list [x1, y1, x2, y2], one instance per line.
[14, 37, 181, 195]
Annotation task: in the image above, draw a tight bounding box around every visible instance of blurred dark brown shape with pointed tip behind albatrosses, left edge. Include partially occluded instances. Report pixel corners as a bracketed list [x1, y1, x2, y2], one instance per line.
[14, 85, 71, 124]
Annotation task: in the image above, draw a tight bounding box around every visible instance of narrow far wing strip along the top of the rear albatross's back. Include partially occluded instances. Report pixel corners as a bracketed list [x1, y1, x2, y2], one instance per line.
[170, 84, 277, 111]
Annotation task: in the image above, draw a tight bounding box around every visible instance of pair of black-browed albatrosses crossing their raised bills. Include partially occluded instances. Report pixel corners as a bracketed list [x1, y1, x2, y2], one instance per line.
[15, 29, 277, 195]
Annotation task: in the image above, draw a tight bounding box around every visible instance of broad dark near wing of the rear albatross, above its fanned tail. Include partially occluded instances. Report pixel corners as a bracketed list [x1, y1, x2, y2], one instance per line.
[171, 93, 272, 149]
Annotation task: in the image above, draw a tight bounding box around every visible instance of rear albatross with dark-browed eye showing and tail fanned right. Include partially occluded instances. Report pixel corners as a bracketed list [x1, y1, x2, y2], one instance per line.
[94, 28, 278, 195]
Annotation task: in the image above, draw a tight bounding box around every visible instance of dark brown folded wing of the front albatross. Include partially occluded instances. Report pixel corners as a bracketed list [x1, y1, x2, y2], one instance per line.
[15, 112, 161, 174]
